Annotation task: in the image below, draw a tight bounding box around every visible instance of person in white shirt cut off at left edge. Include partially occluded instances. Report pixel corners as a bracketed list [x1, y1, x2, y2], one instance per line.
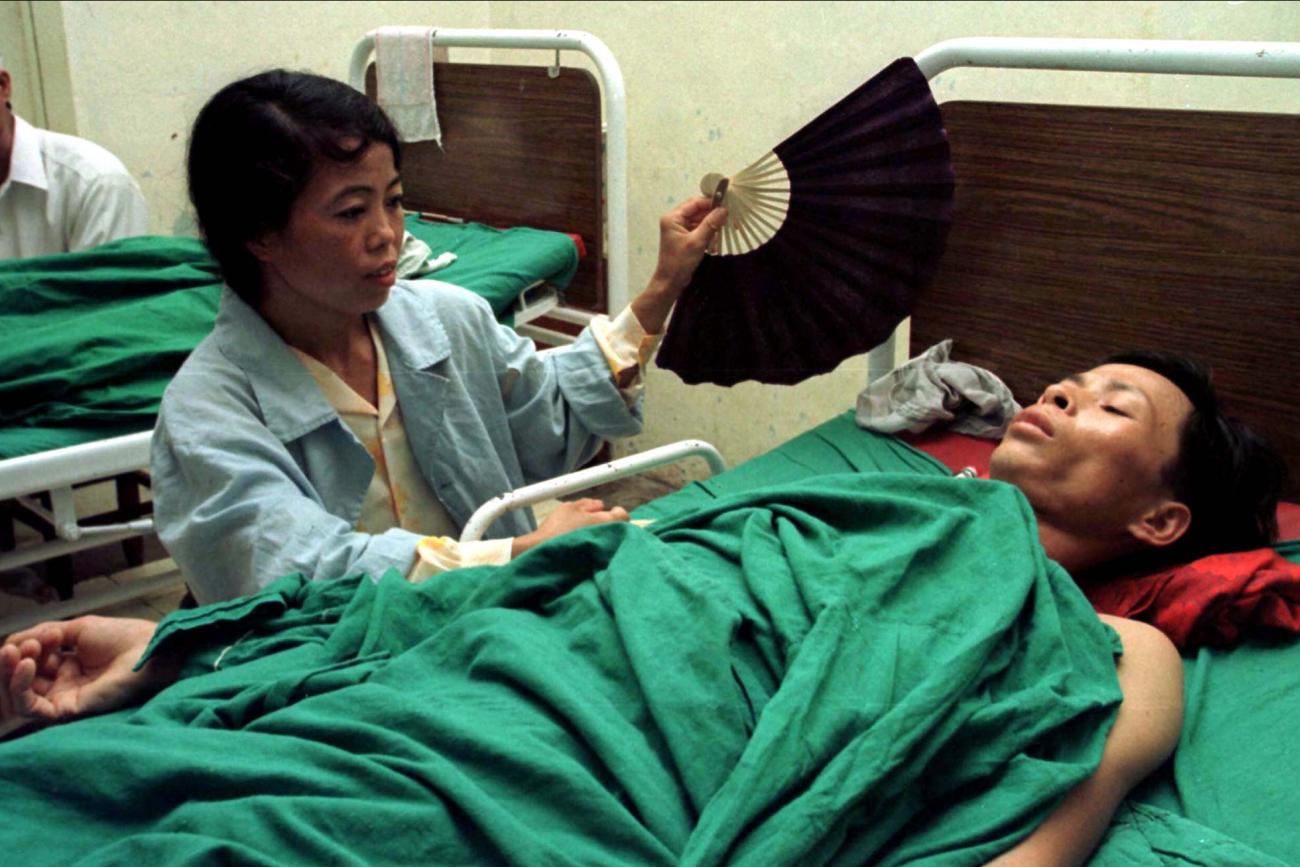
[0, 57, 150, 260]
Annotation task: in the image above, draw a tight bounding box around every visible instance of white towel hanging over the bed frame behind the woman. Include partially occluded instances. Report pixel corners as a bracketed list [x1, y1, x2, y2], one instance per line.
[374, 27, 442, 147]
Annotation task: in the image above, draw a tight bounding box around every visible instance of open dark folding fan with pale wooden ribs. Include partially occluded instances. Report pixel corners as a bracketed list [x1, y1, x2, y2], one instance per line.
[658, 57, 953, 385]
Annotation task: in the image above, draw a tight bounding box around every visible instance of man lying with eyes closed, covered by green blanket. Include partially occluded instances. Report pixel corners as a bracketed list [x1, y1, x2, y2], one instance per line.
[0, 355, 1279, 864]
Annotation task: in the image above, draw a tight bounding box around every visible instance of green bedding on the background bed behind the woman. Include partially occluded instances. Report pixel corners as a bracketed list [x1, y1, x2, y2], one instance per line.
[0, 217, 577, 459]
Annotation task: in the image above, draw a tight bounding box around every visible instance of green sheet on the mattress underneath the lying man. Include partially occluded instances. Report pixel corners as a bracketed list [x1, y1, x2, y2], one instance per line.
[636, 411, 1300, 867]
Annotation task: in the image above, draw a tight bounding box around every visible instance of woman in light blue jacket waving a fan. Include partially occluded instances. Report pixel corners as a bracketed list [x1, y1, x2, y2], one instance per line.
[152, 70, 725, 603]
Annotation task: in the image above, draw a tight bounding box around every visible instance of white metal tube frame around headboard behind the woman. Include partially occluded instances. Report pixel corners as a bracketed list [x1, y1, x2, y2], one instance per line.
[347, 27, 631, 318]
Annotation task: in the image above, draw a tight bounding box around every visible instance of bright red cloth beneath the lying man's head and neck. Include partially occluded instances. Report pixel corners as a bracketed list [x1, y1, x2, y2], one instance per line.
[901, 430, 1300, 651]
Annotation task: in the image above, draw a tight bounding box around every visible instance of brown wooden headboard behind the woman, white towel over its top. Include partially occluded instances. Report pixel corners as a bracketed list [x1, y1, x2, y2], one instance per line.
[365, 62, 606, 311]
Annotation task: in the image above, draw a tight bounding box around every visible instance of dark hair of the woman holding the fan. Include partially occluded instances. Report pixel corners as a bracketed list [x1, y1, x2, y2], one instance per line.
[189, 69, 402, 304]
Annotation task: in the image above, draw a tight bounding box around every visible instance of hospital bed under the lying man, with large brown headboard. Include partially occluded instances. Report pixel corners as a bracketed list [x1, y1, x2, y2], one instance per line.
[467, 38, 1300, 864]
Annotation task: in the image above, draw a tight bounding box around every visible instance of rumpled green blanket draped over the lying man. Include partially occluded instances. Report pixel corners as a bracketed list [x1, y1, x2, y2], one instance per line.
[0, 474, 1118, 864]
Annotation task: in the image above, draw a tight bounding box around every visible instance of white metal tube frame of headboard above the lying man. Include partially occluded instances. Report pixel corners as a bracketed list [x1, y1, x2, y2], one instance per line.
[867, 36, 1300, 380]
